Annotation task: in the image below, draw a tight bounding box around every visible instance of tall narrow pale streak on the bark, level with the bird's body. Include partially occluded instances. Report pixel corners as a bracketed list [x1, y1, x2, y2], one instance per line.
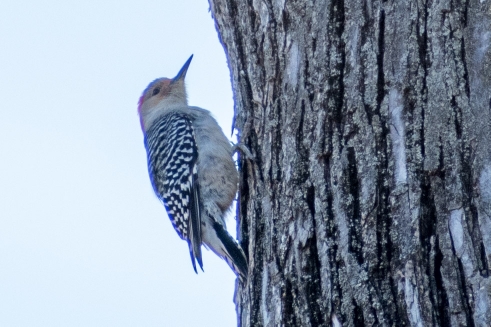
[389, 89, 407, 184]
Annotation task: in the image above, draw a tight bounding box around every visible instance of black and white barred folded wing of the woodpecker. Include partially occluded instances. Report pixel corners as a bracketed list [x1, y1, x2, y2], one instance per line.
[145, 114, 203, 271]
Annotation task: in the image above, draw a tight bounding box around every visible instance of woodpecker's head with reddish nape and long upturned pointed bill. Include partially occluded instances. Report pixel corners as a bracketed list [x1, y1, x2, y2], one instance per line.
[138, 55, 193, 131]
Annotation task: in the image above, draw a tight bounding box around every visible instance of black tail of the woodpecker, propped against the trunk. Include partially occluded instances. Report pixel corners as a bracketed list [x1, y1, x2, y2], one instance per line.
[213, 222, 248, 279]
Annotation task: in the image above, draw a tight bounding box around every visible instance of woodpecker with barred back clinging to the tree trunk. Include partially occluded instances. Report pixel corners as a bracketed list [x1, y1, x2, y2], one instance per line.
[138, 55, 248, 279]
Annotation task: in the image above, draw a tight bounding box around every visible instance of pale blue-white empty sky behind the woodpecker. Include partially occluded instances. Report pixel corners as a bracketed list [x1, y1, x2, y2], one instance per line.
[0, 0, 236, 327]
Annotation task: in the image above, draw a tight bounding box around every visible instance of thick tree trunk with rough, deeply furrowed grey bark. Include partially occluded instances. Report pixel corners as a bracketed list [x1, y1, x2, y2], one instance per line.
[210, 0, 491, 327]
